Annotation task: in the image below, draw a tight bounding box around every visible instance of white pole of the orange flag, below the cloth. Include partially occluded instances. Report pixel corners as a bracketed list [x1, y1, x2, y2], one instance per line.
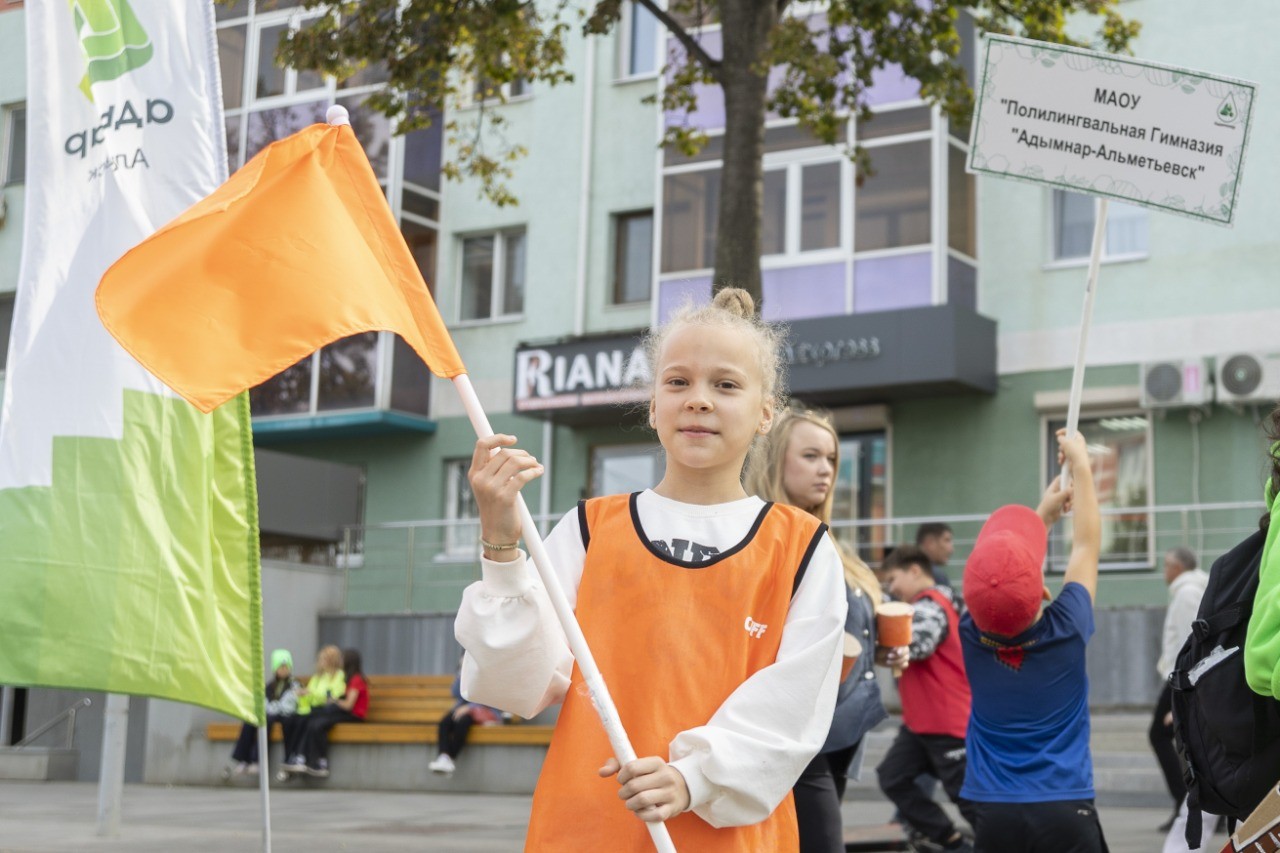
[453, 373, 676, 853]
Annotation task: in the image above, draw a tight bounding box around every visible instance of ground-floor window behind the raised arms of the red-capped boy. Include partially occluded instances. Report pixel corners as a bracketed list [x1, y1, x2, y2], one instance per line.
[1044, 412, 1155, 571]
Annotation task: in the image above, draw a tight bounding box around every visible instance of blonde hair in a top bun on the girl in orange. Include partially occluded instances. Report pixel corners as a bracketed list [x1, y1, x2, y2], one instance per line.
[641, 287, 786, 467]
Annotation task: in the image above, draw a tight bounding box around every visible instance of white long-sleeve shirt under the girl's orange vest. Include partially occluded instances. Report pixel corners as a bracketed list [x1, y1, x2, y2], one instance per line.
[454, 491, 847, 826]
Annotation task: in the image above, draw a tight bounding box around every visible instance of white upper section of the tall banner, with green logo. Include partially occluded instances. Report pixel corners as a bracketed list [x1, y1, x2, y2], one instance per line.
[0, 0, 227, 488]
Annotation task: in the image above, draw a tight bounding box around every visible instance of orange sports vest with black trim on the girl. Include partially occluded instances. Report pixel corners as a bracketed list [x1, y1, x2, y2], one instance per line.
[525, 494, 826, 853]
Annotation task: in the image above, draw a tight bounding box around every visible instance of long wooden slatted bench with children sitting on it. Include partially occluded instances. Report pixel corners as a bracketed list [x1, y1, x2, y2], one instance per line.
[205, 675, 553, 747]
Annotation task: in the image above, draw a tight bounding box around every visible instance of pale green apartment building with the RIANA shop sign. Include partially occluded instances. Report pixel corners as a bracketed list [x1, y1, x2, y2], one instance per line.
[0, 0, 1280, 613]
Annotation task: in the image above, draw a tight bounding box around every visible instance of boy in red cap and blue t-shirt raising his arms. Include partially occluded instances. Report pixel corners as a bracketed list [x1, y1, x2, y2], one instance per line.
[960, 430, 1107, 853]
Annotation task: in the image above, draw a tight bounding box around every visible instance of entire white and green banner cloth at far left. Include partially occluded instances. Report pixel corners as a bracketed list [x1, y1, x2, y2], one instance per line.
[0, 0, 264, 721]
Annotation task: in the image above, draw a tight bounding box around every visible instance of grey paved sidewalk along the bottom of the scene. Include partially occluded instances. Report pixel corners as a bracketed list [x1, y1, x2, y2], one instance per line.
[0, 783, 1222, 853]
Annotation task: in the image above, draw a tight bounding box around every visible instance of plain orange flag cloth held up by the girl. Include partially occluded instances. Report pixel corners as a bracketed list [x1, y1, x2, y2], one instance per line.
[96, 124, 466, 412]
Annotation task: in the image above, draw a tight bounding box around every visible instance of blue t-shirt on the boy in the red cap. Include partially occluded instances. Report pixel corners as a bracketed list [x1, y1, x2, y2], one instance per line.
[960, 583, 1093, 803]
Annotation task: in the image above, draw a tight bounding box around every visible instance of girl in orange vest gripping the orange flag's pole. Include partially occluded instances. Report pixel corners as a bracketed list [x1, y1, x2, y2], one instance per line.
[456, 289, 846, 853]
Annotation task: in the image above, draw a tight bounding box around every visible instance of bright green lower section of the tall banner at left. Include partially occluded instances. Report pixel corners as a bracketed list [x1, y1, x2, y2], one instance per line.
[0, 391, 265, 725]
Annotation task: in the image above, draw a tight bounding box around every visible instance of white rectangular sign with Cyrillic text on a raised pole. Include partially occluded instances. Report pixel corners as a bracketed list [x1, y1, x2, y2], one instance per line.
[968, 35, 1257, 225]
